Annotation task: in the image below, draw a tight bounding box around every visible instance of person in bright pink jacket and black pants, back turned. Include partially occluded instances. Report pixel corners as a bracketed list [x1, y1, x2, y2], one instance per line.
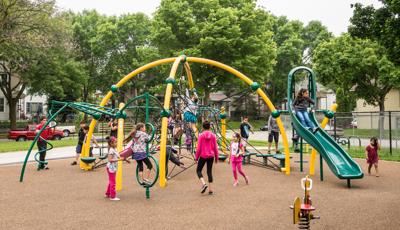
[195, 121, 218, 195]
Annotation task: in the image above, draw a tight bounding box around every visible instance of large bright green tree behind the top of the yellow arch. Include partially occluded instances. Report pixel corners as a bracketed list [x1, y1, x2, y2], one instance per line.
[152, 0, 276, 104]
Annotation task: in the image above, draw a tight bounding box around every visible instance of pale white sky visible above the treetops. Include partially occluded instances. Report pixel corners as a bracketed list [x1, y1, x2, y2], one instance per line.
[56, 0, 381, 36]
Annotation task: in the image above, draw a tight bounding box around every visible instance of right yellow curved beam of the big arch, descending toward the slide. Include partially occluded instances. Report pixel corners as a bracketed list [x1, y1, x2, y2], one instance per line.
[186, 57, 290, 175]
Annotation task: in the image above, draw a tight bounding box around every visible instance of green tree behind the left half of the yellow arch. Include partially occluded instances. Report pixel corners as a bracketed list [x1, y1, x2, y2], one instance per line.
[93, 13, 164, 101]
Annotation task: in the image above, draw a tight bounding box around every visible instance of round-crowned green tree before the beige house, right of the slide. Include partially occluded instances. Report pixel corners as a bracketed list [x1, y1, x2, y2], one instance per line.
[313, 34, 400, 116]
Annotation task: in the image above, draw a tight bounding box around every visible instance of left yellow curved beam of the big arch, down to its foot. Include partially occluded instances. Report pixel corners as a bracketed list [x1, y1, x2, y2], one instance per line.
[80, 58, 175, 170]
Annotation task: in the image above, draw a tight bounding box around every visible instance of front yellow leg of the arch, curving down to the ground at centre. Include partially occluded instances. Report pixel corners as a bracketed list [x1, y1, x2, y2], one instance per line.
[159, 56, 184, 188]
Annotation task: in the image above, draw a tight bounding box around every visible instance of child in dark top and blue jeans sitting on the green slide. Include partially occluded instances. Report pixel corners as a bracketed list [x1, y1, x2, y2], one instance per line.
[293, 88, 318, 132]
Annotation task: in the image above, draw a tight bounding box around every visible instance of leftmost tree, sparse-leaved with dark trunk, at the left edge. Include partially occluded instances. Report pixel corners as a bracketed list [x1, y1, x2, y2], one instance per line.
[0, 0, 84, 129]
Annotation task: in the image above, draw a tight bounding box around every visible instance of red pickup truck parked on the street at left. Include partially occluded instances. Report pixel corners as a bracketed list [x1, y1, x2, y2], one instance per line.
[8, 125, 64, 141]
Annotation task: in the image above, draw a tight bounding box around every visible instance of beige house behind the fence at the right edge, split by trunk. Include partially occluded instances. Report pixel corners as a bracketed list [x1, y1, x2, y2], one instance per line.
[353, 89, 400, 129]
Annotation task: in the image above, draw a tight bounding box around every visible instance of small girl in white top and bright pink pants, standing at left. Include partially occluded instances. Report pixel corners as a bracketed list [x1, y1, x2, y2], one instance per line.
[105, 137, 120, 201]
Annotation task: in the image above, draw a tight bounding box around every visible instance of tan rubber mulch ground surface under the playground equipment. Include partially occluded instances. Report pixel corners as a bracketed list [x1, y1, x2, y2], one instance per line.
[0, 153, 400, 230]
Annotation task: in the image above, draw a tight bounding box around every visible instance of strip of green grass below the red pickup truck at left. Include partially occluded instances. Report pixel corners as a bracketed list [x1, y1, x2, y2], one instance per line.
[0, 139, 77, 153]
